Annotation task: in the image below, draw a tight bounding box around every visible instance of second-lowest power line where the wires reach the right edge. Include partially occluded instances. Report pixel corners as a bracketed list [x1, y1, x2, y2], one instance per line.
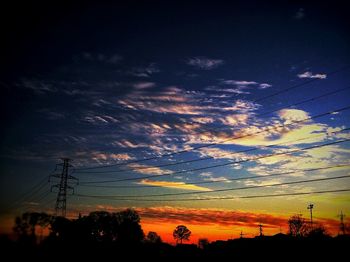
[77, 175, 350, 199]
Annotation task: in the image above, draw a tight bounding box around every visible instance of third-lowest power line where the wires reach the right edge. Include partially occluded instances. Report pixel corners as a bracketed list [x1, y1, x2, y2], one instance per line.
[80, 164, 350, 188]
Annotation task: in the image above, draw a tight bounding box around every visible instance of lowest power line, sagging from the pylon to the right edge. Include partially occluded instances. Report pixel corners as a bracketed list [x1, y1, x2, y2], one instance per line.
[73, 188, 350, 202]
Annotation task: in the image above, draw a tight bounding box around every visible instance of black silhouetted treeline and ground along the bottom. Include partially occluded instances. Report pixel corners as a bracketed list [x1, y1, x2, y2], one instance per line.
[0, 209, 350, 261]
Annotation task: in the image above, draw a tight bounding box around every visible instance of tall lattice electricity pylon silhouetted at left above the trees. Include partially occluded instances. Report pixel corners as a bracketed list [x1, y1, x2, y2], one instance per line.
[49, 158, 78, 217]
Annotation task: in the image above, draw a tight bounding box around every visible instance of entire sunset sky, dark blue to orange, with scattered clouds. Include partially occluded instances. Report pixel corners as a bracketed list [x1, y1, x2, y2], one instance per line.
[0, 1, 350, 243]
